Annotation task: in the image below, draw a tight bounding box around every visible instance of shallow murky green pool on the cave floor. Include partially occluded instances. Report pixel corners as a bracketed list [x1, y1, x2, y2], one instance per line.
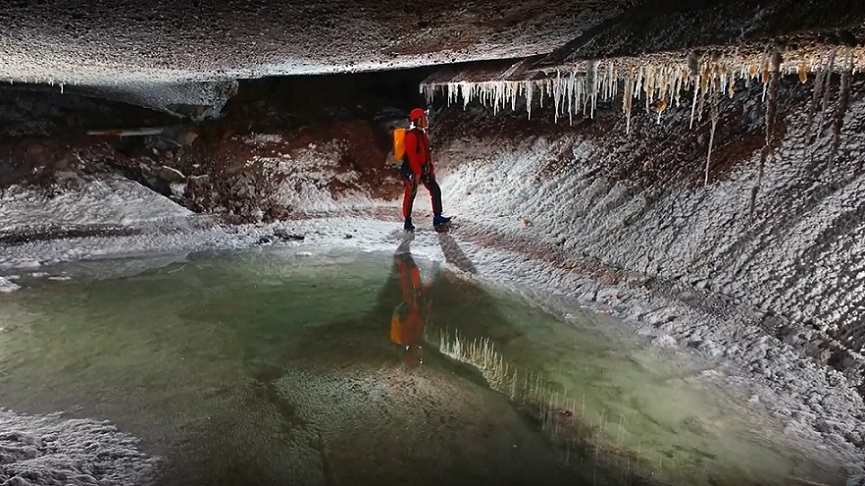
[0, 247, 841, 485]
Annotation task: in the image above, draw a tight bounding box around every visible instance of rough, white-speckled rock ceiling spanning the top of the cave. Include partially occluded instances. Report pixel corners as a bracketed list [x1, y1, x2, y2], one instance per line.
[0, 0, 865, 115]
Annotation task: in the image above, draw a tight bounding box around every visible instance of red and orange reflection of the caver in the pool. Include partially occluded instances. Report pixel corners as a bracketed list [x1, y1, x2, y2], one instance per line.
[390, 242, 439, 366]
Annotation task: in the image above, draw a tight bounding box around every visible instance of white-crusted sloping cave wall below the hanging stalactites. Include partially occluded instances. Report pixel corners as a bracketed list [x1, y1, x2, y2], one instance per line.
[438, 79, 865, 369]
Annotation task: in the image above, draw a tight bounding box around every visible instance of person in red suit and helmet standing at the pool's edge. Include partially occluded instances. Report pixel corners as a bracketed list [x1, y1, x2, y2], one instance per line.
[400, 108, 451, 231]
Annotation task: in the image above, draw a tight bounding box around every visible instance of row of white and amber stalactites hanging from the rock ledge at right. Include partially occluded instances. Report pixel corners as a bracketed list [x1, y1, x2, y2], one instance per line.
[421, 45, 865, 208]
